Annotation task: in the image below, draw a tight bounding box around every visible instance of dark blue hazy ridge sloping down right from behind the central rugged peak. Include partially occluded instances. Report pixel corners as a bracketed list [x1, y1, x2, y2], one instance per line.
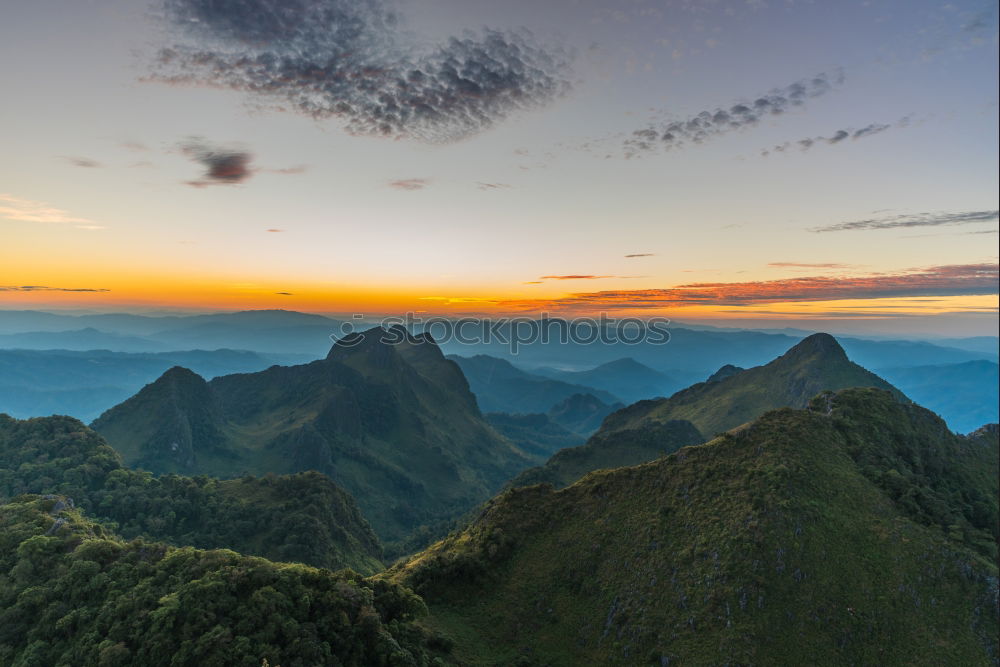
[448, 354, 618, 414]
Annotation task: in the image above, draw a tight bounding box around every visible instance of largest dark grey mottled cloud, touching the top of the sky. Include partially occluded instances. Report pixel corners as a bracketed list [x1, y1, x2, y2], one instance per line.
[150, 0, 569, 142]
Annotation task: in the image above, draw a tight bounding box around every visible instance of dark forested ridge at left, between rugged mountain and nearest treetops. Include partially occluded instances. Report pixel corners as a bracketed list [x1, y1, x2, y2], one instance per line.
[0, 415, 382, 573]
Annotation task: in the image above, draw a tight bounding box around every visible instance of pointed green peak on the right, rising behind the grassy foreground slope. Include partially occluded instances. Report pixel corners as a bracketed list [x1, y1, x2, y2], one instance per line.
[599, 334, 906, 437]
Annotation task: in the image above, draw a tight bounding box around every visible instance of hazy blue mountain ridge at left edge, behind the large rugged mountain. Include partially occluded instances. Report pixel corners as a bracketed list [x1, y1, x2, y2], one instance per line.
[0, 350, 308, 421]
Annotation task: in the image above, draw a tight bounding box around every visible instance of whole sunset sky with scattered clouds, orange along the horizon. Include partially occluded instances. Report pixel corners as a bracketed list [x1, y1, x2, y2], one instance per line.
[0, 0, 1000, 335]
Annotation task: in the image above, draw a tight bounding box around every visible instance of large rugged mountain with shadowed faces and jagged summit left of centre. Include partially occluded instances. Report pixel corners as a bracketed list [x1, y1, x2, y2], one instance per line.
[94, 327, 537, 540]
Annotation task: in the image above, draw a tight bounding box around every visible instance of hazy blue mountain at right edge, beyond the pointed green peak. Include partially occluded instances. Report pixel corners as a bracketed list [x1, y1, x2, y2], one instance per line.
[879, 361, 1000, 433]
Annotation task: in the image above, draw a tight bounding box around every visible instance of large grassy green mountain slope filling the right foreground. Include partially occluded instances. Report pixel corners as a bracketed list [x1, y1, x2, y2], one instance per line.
[385, 389, 998, 666]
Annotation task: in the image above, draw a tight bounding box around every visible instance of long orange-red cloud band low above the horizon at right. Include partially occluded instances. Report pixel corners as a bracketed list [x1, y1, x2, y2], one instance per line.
[505, 264, 1000, 310]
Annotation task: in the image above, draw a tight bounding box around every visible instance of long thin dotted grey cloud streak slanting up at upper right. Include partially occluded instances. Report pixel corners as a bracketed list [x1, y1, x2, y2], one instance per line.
[625, 71, 844, 156]
